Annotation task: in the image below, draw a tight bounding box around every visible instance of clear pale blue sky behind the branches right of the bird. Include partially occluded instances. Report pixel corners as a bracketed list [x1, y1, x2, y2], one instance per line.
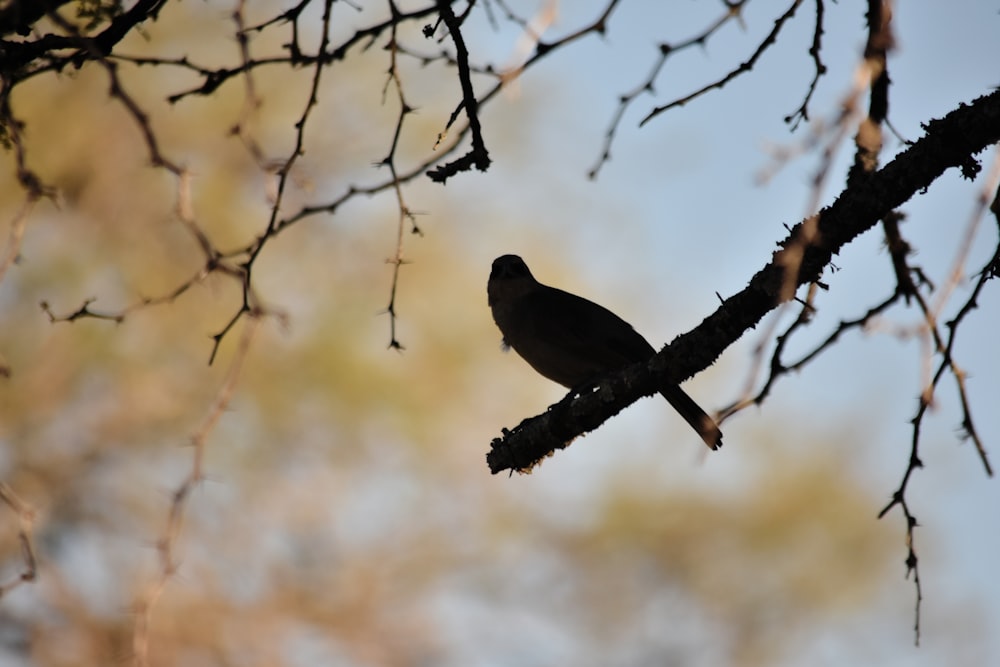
[413, 1, 1000, 664]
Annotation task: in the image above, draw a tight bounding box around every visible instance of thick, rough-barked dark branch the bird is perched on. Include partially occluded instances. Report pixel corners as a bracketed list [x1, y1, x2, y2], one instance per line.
[486, 91, 1000, 474]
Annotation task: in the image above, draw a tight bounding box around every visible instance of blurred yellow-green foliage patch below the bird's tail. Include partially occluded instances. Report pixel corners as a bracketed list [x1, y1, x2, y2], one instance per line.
[566, 443, 898, 665]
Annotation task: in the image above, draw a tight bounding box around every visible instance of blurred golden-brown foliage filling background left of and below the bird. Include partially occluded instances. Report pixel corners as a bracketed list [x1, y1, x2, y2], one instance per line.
[0, 2, 952, 665]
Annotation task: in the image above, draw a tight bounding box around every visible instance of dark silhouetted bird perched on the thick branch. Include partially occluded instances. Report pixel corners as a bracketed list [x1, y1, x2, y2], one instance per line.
[486, 255, 722, 449]
